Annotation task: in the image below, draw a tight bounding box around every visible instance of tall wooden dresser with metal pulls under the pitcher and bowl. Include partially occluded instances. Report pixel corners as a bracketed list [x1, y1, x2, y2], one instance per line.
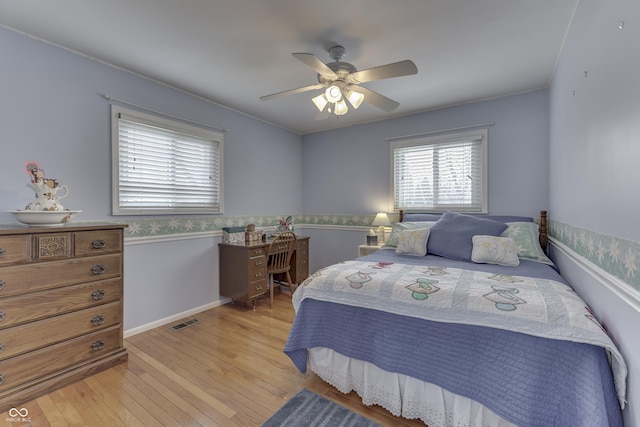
[0, 224, 127, 412]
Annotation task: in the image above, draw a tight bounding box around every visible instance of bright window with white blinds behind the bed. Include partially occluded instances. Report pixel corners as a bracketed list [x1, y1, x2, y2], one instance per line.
[391, 130, 487, 213]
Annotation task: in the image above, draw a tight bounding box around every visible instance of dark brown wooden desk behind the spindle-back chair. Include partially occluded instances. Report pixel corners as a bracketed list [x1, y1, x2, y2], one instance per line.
[218, 236, 309, 305]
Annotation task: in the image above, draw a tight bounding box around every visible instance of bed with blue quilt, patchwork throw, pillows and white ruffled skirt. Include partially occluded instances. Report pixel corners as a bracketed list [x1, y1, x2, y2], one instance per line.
[284, 211, 627, 427]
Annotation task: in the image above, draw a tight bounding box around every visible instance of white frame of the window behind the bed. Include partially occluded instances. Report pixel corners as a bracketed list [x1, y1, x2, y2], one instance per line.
[390, 129, 489, 214]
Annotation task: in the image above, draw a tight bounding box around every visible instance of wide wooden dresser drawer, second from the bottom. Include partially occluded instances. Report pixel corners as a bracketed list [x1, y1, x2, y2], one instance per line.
[0, 302, 122, 360]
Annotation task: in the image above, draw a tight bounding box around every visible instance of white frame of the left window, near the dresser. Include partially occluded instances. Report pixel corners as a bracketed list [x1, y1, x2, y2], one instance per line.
[111, 105, 224, 216]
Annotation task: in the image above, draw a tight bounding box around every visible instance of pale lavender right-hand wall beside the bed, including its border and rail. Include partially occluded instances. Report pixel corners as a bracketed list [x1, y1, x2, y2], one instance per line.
[550, 0, 640, 426]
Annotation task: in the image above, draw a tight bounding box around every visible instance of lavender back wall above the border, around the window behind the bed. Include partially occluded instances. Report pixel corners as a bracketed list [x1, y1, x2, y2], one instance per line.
[303, 90, 549, 216]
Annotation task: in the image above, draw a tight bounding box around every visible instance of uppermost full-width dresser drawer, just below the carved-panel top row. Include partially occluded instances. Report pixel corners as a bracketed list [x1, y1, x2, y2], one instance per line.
[0, 254, 122, 297]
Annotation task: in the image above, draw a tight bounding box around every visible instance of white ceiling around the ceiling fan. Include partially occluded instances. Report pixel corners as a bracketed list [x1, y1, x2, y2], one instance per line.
[0, 0, 578, 134]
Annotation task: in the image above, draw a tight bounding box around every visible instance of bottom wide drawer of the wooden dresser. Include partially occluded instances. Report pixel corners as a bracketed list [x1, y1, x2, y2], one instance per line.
[0, 326, 122, 391]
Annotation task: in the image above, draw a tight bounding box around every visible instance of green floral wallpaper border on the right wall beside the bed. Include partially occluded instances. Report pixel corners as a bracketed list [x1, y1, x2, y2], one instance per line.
[549, 221, 640, 292]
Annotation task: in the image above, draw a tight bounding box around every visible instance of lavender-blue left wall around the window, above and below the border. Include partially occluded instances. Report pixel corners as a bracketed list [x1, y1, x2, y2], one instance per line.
[0, 28, 302, 332]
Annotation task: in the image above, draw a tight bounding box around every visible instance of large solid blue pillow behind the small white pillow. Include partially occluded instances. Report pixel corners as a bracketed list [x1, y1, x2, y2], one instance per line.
[427, 211, 507, 261]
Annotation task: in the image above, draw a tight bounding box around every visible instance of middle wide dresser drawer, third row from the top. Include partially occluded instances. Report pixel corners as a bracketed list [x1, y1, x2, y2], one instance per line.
[0, 278, 122, 329]
